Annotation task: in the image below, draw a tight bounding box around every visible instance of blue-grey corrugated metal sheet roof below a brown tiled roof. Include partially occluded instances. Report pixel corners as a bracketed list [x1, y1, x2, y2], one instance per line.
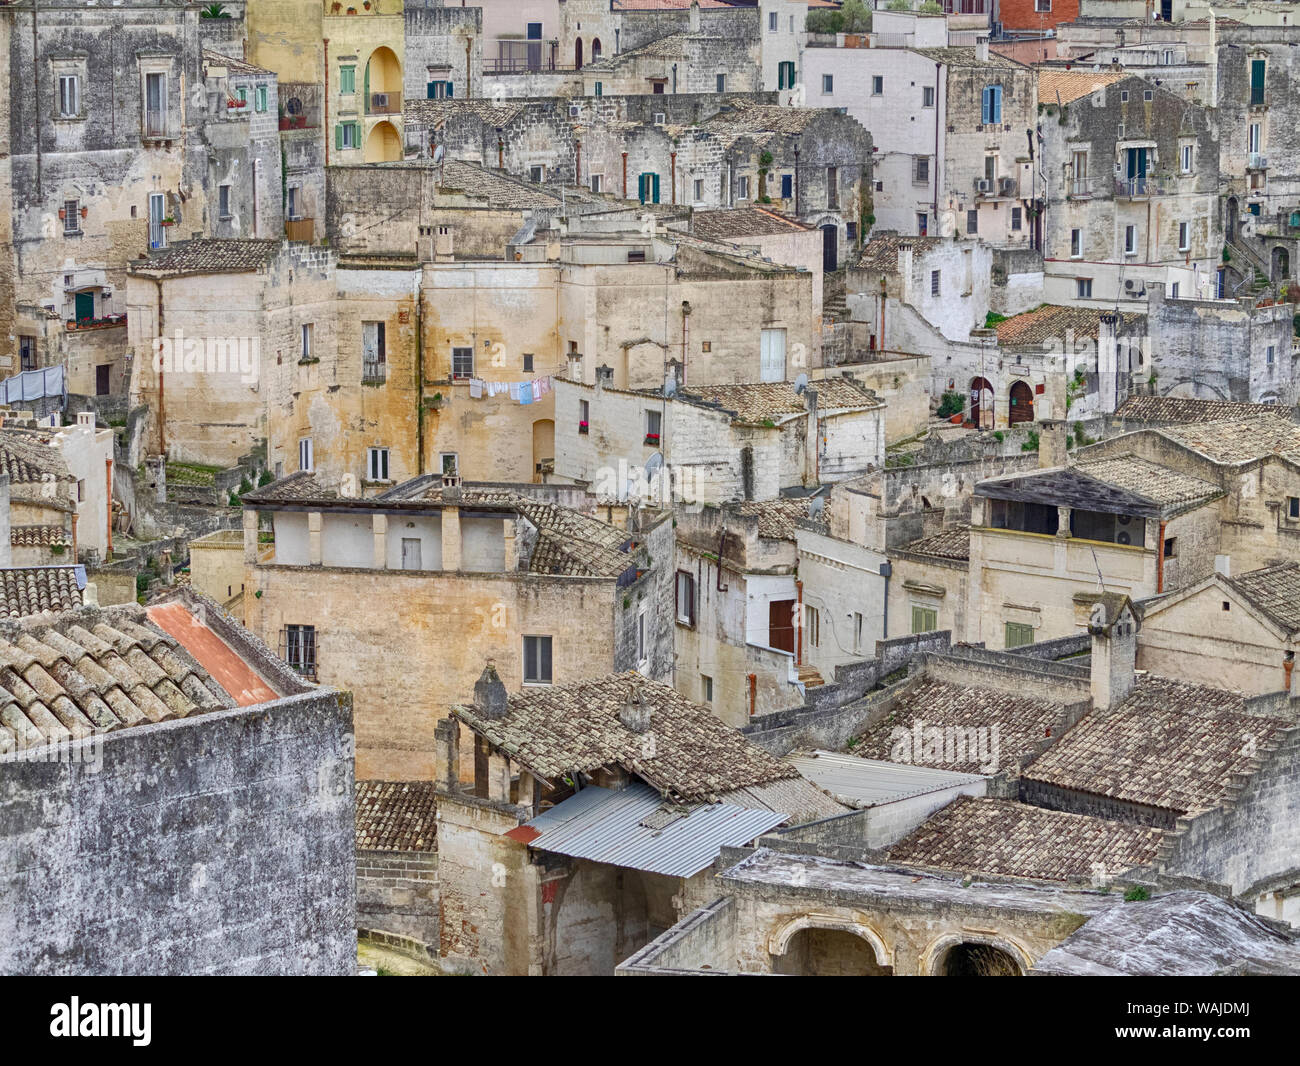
[507, 783, 785, 878]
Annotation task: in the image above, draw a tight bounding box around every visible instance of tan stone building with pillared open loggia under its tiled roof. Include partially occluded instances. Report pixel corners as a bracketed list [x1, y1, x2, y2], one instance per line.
[243, 473, 672, 781]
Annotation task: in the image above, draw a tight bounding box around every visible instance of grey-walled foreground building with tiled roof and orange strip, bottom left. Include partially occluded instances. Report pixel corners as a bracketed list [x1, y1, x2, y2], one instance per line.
[0, 594, 356, 976]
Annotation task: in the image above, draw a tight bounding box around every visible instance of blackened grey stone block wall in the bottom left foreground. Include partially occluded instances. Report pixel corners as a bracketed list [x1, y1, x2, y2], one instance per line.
[0, 692, 356, 975]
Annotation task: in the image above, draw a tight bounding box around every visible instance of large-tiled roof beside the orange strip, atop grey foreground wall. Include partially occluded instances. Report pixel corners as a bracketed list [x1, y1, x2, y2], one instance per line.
[0, 605, 235, 753]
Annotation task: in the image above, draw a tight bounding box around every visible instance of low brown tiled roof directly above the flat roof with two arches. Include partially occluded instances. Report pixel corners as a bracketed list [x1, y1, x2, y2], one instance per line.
[889, 797, 1164, 881]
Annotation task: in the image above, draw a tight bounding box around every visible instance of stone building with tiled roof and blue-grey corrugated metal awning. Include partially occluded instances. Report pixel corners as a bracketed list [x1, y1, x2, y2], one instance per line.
[437, 662, 844, 976]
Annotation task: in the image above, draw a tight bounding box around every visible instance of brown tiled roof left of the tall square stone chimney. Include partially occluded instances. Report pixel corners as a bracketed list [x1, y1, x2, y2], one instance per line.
[849, 677, 1065, 774]
